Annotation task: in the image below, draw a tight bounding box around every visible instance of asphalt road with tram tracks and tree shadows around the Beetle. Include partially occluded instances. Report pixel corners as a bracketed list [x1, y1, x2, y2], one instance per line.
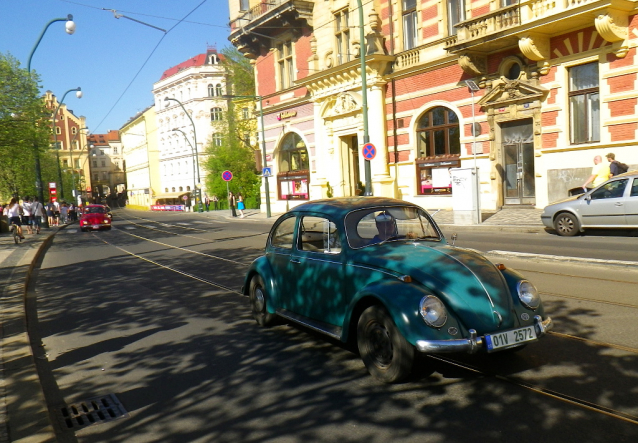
[31, 211, 638, 443]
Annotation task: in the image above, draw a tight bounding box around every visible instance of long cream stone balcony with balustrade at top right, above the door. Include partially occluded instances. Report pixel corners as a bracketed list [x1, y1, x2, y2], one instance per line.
[446, 0, 638, 53]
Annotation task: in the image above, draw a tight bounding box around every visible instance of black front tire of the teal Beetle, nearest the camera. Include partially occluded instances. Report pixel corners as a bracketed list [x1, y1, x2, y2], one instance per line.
[357, 305, 415, 383]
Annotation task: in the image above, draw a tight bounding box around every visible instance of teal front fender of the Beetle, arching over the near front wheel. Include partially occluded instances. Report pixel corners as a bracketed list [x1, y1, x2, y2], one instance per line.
[342, 279, 469, 346]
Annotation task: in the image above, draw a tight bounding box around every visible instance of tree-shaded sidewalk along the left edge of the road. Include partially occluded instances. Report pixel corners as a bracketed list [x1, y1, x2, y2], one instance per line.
[0, 228, 58, 443]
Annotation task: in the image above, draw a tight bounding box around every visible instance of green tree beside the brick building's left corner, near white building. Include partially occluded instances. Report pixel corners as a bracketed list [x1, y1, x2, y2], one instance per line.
[204, 47, 261, 208]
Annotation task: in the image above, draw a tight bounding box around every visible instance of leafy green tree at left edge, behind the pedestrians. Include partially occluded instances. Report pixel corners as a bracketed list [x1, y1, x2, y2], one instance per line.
[0, 53, 55, 203]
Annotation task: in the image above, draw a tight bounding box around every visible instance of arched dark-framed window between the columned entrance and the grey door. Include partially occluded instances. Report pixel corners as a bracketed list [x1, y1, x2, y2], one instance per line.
[416, 106, 461, 195]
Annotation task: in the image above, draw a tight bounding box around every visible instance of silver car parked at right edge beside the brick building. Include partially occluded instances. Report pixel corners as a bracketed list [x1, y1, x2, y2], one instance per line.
[541, 171, 638, 236]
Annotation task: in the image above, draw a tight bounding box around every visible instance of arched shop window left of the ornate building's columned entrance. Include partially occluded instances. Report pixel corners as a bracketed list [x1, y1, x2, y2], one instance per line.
[277, 132, 310, 200]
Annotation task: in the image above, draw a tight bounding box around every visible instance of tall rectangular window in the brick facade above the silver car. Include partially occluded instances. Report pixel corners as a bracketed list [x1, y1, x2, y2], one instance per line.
[569, 63, 600, 144]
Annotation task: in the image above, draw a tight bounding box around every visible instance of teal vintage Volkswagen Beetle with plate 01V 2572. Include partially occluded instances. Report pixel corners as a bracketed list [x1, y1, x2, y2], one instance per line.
[243, 197, 552, 383]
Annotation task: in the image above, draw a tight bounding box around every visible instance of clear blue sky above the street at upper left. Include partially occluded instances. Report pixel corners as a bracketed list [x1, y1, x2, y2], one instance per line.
[0, 0, 230, 133]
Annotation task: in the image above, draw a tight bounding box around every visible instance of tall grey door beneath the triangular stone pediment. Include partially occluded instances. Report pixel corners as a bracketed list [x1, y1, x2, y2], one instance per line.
[501, 119, 536, 205]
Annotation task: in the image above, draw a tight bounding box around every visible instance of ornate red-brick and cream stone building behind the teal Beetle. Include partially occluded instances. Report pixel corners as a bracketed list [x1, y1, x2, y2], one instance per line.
[229, 0, 638, 210]
